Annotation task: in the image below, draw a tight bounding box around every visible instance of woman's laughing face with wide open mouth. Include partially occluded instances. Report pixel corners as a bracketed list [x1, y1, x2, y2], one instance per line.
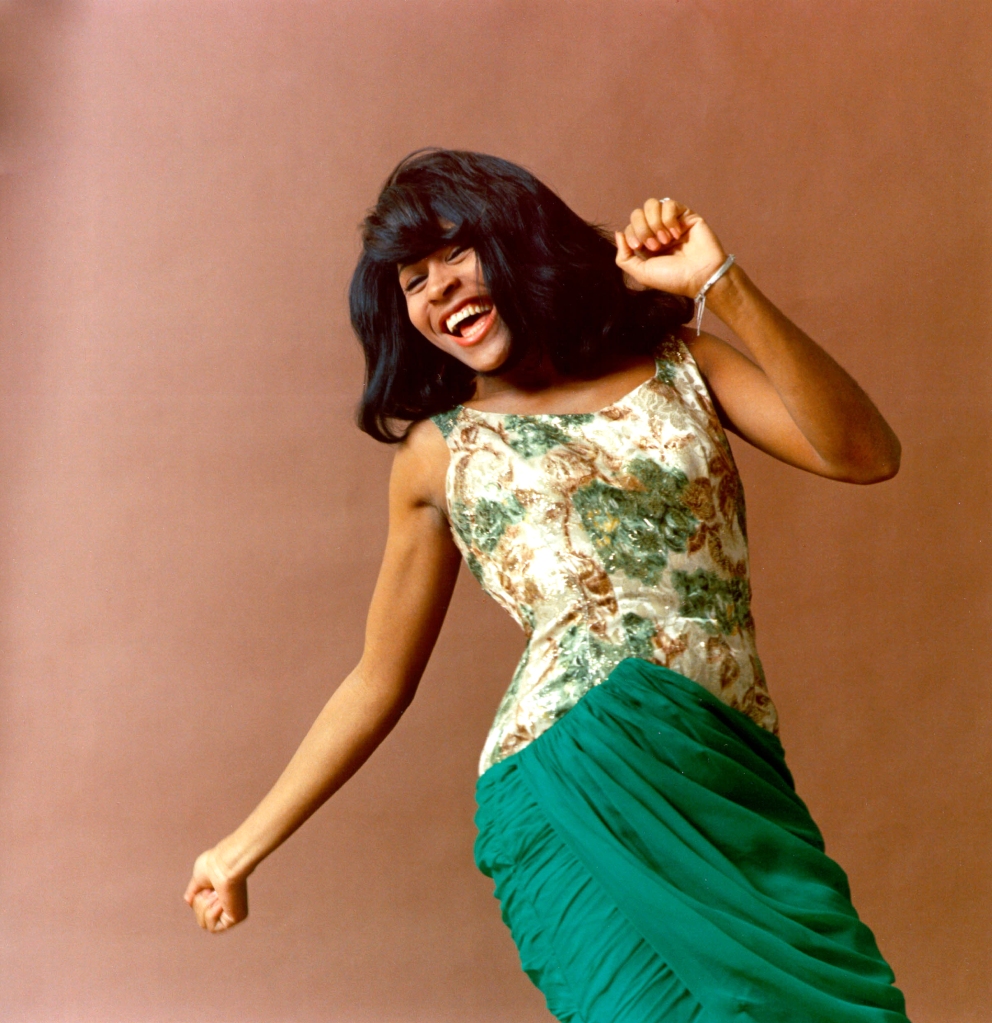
[399, 246, 510, 373]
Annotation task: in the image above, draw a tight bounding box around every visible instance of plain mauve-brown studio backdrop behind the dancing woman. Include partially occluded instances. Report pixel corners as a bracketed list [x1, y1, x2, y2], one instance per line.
[0, 0, 992, 1023]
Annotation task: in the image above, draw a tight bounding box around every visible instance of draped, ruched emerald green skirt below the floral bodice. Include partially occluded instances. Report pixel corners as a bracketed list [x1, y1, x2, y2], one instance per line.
[476, 658, 906, 1023]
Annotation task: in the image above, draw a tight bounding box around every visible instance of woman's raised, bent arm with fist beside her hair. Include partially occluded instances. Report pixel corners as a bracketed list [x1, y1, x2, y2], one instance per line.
[617, 199, 900, 483]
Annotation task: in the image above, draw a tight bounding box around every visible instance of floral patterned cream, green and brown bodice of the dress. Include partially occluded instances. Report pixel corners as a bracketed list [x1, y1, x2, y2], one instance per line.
[434, 338, 777, 772]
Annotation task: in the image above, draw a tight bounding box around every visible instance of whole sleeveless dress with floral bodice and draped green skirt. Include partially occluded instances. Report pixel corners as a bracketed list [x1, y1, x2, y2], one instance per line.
[434, 337, 906, 1023]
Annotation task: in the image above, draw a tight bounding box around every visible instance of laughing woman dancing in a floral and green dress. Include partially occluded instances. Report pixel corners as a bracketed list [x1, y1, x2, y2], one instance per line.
[186, 150, 905, 1023]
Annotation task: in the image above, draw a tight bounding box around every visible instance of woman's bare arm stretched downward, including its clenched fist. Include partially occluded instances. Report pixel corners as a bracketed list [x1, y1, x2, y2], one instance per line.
[185, 422, 460, 932]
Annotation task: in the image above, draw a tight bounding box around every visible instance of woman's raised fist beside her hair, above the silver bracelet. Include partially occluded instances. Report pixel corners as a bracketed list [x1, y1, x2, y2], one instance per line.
[616, 198, 727, 299]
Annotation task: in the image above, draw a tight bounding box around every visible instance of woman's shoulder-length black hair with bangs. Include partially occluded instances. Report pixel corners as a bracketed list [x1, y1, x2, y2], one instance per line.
[349, 148, 692, 443]
